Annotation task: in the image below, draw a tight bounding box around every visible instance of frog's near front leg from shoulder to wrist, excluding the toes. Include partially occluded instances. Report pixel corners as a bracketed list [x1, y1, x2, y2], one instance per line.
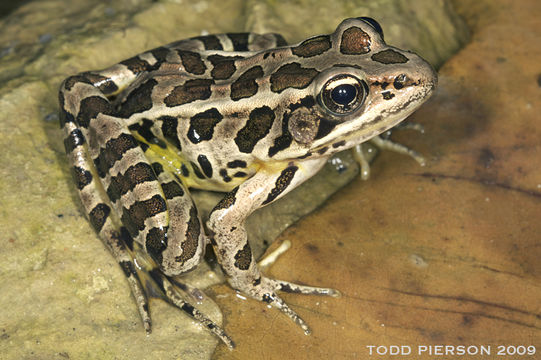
[208, 159, 325, 291]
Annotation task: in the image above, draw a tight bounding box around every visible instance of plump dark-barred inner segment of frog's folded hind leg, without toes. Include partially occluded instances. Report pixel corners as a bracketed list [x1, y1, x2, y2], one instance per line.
[89, 114, 204, 275]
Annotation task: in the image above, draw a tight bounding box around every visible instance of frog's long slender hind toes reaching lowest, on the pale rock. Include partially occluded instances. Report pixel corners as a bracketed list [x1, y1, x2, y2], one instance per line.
[148, 268, 235, 349]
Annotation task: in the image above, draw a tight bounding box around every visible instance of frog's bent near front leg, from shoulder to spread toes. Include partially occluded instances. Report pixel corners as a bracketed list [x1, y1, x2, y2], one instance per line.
[207, 159, 339, 334]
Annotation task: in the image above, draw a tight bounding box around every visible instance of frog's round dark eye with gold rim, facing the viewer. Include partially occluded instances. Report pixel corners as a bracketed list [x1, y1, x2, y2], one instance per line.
[320, 75, 368, 115]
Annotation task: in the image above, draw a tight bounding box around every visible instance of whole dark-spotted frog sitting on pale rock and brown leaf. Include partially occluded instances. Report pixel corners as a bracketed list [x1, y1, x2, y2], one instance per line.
[59, 17, 437, 348]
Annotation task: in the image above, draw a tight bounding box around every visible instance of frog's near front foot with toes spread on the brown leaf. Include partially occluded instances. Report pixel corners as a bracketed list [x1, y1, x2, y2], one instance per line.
[235, 276, 340, 335]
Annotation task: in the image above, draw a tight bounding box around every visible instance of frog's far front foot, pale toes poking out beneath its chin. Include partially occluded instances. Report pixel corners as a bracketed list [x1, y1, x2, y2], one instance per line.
[353, 122, 426, 180]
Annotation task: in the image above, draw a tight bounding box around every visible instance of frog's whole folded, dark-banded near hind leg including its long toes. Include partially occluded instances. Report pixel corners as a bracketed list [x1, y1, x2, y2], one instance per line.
[60, 77, 233, 347]
